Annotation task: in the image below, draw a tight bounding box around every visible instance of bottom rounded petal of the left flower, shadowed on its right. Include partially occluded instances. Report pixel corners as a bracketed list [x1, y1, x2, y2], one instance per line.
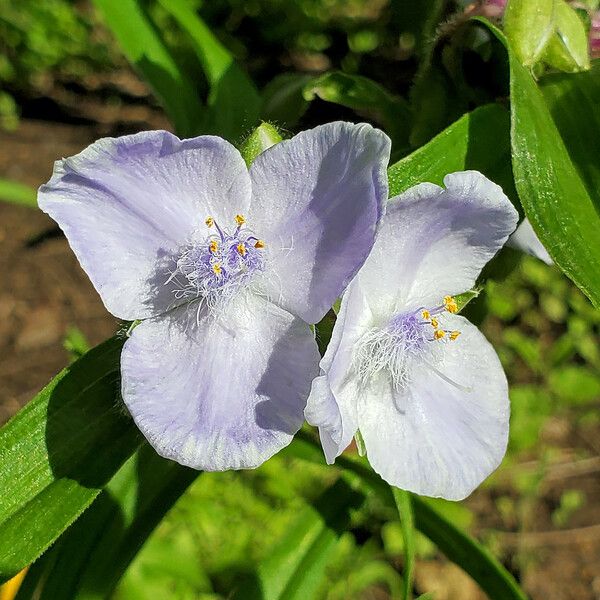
[121, 295, 319, 471]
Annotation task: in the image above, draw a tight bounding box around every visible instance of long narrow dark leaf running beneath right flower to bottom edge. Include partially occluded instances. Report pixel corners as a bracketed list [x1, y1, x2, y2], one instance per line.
[286, 431, 527, 600]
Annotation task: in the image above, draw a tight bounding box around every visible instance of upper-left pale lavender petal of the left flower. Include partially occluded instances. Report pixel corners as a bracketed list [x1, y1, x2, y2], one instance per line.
[38, 131, 251, 320]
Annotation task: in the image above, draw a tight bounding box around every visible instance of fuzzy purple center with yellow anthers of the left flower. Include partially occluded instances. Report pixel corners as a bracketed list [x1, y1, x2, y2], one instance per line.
[168, 215, 265, 309]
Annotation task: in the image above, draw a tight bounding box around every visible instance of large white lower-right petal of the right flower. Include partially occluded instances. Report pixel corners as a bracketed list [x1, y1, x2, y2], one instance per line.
[358, 315, 510, 500]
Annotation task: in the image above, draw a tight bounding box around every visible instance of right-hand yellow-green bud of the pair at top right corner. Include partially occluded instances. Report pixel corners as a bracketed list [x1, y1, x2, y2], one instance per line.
[544, 0, 590, 73]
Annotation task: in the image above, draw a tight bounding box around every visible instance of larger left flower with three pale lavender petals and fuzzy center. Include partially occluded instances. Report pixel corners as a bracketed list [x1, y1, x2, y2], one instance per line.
[38, 122, 390, 470]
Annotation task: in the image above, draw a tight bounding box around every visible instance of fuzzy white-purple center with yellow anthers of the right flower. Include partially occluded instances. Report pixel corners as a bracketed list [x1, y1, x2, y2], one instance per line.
[353, 296, 460, 389]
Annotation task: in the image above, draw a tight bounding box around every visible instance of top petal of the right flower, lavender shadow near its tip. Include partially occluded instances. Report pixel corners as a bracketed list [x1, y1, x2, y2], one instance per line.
[358, 171, 517, 319]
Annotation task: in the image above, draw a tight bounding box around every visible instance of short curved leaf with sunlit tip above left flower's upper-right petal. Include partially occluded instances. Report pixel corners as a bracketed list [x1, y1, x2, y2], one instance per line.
[304, 71, 410, 146]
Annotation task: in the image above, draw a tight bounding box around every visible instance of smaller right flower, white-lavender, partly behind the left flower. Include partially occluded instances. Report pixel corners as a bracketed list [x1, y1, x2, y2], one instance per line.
[305, 171, 517, 499]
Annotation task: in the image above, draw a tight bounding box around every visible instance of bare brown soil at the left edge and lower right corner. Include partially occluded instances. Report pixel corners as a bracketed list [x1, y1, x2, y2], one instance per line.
[0, 90, 600, 600]
